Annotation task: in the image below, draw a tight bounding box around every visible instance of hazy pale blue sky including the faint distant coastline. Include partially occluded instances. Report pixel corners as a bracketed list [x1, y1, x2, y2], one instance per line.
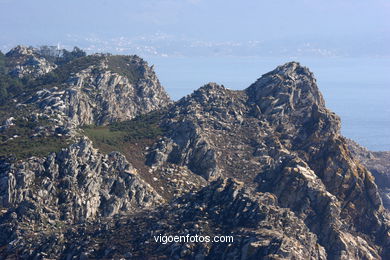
[0, 0, 390, 56]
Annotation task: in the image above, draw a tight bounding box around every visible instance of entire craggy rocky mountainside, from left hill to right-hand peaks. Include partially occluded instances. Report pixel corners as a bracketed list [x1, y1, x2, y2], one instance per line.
[0, 47, 390, 259]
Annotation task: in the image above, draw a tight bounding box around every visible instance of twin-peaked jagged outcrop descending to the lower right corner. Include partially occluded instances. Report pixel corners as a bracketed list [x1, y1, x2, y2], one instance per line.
[145, 62, 389, 259]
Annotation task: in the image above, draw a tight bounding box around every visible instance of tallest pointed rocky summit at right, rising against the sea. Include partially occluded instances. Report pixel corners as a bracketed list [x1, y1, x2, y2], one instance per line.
[245, 62, 341, 143]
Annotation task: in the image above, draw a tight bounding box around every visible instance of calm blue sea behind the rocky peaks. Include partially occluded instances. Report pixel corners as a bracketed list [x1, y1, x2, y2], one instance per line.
[145, 57, 390, 151]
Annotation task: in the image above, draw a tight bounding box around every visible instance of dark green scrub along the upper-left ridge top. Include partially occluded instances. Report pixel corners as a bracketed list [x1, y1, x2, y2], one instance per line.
[0, 46, 145, 106]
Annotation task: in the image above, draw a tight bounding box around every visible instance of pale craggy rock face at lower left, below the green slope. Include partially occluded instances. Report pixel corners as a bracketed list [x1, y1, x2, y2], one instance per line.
[0, 139, 163, 224]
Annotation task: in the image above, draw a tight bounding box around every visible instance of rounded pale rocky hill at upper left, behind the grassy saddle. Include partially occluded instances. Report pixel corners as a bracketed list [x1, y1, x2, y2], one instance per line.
[0, 46, 171, 148]
